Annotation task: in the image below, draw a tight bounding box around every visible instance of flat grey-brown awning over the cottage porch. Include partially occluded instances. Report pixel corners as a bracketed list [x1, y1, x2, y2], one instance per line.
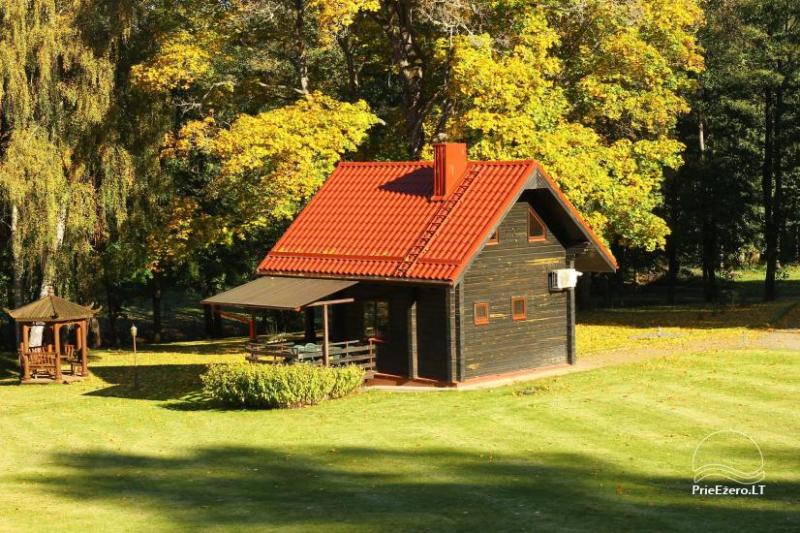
[202, 276, 358, 309]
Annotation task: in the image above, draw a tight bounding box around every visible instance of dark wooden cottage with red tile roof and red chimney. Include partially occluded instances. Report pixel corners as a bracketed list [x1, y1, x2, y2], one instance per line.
[206, 143, 616, 384]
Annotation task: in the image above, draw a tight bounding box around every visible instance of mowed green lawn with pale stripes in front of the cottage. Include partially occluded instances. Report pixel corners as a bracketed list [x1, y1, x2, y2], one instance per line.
[0, 342, 800, 531]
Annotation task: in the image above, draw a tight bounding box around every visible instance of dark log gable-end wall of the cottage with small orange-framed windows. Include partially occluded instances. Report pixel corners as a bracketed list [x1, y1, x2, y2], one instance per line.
[459, 201, 567, 379]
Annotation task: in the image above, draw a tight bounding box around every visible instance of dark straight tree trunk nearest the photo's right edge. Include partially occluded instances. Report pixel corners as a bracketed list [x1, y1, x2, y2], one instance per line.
[761, 89, 778, 300]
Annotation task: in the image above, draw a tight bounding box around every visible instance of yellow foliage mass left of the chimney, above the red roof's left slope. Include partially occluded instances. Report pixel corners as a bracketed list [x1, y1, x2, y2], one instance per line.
[163, 93, 378, 235]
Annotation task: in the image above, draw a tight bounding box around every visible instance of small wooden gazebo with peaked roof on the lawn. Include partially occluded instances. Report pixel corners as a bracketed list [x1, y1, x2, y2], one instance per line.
[5, 294, 96, 383]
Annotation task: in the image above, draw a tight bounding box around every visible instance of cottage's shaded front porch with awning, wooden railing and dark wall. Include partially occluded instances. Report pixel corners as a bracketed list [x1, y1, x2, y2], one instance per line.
[202, 276, 459, 386]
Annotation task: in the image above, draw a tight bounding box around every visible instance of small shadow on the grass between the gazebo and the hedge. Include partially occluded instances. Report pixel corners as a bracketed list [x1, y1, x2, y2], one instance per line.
[86, 364, 206, 409]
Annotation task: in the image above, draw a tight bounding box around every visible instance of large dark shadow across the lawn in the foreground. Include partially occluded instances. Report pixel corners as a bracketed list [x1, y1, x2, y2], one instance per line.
[19, 447, 800, 531]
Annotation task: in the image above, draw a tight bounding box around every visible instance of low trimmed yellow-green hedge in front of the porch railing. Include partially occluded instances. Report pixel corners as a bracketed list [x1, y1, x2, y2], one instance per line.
[200, 362, 364, 409]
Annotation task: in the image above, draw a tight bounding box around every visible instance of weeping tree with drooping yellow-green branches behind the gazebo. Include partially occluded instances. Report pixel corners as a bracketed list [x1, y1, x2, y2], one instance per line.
[0, 0, 133, 305]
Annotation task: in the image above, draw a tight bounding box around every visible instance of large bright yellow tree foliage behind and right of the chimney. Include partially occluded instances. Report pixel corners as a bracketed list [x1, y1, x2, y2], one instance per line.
[441, 0, 702, 250]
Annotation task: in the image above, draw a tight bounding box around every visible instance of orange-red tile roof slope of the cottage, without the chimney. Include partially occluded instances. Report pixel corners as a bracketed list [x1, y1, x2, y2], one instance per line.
[258, 161, 610, 282]
